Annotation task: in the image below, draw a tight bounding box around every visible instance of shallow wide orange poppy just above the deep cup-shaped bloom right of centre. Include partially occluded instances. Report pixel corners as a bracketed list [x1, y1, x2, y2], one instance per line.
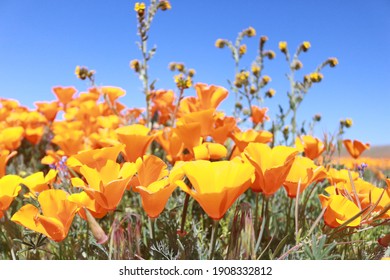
[232, 129, 273, 152]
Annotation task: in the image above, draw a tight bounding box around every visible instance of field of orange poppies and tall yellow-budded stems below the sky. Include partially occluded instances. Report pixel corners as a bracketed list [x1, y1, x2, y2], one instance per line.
[0, 0, 390, 260]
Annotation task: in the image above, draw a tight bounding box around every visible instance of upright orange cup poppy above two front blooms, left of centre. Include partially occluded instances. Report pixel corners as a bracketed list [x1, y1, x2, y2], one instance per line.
[115, 124, 155, 162]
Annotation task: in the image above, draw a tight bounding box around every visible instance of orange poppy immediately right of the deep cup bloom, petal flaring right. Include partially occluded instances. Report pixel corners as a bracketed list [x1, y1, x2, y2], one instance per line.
[283, 156, 327, 197]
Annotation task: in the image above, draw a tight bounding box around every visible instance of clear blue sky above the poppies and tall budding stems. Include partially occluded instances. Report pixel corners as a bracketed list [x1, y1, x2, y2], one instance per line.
[0, 0, 390, 145]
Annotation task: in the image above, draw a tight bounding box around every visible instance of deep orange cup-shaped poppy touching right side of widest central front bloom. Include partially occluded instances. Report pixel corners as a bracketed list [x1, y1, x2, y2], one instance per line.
[244, 143, 298, 195]
